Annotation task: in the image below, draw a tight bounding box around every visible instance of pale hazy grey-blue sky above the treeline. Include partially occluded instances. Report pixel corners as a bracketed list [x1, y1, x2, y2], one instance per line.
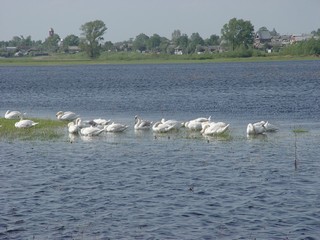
[0, 0, 320, 42]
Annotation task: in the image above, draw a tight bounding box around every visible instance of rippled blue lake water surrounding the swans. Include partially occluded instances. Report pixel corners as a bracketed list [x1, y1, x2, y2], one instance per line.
[0, 61, 320, 239]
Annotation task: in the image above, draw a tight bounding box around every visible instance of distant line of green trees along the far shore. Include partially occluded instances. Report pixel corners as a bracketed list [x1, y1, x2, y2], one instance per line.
[0, 18, 320, 58]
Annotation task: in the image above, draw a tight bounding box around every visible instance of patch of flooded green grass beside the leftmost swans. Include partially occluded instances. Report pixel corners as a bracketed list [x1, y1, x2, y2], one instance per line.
[0, 118, 67, 141]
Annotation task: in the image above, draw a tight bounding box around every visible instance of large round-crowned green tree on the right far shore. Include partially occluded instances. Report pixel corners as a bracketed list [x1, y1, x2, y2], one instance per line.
[221, 18, 254, 51]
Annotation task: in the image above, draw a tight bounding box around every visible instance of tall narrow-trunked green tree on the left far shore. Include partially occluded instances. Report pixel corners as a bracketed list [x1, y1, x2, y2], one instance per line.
[80, 20, 107, 58]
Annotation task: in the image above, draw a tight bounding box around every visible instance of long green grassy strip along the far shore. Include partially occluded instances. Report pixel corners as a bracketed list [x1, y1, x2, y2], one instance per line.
[0, 52, 319, 66]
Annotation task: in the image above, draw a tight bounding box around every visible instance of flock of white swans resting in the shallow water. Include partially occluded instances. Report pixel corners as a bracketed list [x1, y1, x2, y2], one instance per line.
[5, 110, 278, 137]
